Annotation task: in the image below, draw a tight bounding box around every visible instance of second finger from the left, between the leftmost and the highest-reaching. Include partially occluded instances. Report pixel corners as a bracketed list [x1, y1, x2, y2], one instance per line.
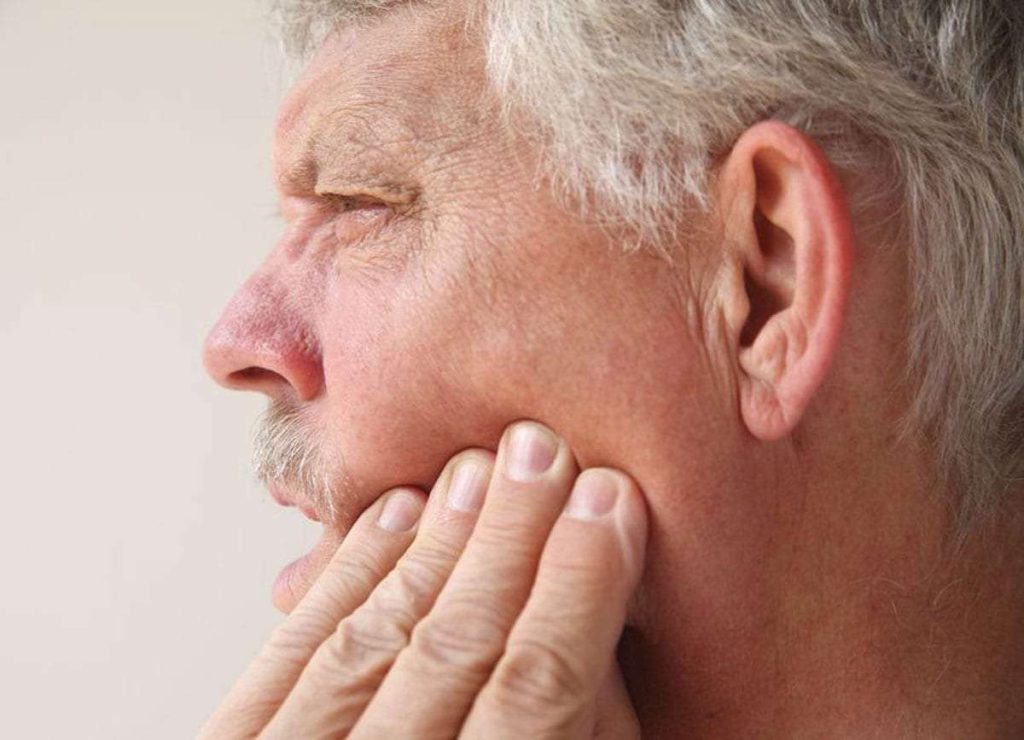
[263, 450, 494, 738]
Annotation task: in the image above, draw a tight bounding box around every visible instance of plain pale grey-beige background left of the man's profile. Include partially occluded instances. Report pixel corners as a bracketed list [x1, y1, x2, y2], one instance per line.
[0, 0, 316, 738]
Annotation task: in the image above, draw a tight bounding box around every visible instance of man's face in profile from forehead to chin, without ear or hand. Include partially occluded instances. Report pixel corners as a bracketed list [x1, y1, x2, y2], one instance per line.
[207, 5, 727, 610]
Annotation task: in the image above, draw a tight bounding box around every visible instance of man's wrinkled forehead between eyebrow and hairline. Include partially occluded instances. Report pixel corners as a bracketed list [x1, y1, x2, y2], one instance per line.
[274, 6, 483, 189]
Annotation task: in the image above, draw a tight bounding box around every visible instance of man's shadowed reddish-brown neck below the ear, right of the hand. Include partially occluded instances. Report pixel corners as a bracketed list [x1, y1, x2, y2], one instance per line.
[621, 417, 1024, 737]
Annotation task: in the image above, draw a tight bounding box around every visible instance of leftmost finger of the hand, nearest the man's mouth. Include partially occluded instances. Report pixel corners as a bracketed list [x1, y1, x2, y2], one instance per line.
[200, 488, 425, 738]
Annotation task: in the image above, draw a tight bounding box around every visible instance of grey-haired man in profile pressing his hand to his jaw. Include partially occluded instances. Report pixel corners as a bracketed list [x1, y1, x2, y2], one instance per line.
[199, 0, 1024, 738]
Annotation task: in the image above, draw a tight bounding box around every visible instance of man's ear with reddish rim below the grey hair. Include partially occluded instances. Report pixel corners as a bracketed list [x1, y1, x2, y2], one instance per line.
[719, 121, 853, 441]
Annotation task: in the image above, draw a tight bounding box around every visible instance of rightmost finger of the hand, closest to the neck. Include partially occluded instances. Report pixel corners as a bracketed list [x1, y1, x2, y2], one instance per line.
[463, 469, 646, 738]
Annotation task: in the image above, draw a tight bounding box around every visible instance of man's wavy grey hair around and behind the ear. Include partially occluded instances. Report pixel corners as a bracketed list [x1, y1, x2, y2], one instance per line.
[276, 0, 1024, 523]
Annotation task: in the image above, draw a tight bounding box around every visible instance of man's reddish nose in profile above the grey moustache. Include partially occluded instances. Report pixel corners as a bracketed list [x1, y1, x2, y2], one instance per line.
[203, 275, 324, 401]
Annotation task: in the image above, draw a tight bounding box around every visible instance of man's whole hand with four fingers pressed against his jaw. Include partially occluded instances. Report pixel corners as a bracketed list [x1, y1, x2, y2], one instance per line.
[202, 422, 647, 739]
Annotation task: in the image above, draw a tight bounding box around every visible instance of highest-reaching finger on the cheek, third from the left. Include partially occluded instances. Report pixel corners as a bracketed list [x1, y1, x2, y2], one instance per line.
[350, 423, 577, 738]
